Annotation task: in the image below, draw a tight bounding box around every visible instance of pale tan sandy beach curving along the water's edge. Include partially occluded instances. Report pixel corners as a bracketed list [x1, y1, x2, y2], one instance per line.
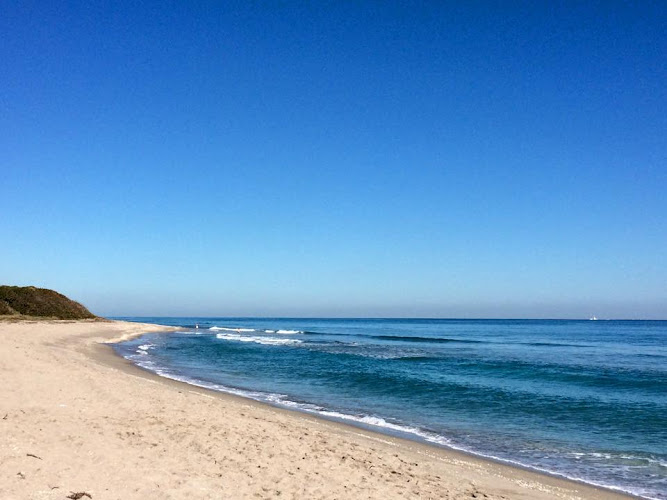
[0, 321, 628, 500]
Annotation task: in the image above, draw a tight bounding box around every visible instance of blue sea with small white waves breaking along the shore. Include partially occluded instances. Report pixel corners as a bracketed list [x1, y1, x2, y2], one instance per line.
[116, 318, 667, 499]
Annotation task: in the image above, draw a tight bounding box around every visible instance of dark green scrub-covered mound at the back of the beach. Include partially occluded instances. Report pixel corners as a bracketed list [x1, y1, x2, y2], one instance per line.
[0, 285, 97, 319]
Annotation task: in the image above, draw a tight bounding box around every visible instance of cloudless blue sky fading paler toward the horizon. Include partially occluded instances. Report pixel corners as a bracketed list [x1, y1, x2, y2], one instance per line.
[0, 0, 667, 318]
